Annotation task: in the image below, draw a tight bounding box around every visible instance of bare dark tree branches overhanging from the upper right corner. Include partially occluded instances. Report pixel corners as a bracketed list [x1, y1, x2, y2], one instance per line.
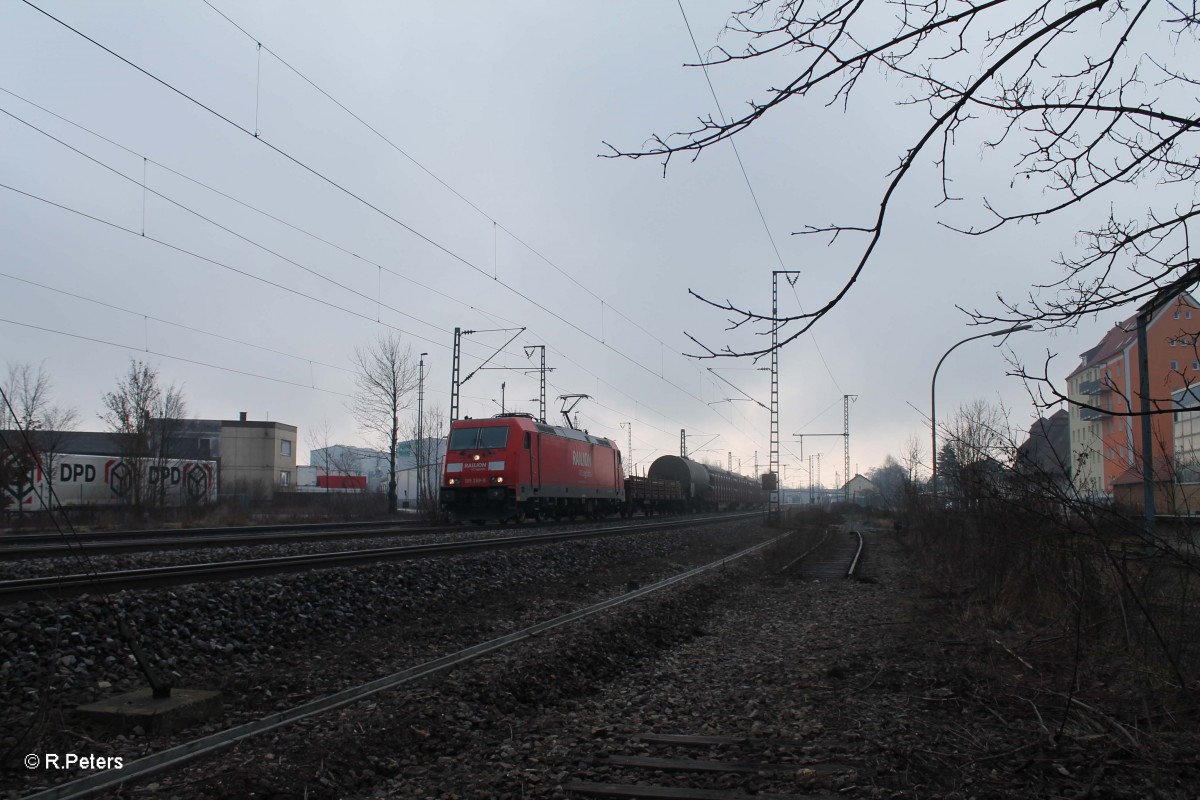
[610, 0, 1200, 359]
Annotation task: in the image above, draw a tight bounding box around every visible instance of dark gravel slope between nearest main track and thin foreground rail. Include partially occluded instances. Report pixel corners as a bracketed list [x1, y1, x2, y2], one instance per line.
[0, 525, 777, 796]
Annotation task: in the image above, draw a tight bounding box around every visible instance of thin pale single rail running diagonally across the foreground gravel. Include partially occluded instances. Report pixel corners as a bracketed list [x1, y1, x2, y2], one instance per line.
[24, 531, 791, 800]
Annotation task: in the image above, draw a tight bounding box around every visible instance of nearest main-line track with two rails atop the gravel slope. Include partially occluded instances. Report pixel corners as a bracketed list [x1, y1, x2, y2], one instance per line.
[0, 512, 757, 606]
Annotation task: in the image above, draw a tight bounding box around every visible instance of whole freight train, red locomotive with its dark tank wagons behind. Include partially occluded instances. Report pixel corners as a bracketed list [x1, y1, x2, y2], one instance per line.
[439, 414, 766, 521]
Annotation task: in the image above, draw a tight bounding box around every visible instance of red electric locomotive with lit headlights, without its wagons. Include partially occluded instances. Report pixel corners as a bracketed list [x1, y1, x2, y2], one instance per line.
[439, 414, 625, 521]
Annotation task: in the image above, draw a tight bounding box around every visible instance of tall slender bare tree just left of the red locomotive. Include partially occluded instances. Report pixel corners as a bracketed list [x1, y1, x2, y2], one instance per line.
[350, 332, 416, 515]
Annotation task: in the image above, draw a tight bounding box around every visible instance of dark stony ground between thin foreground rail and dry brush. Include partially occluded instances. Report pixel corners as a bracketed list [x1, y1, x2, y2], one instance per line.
[9, 522, 1200, 800]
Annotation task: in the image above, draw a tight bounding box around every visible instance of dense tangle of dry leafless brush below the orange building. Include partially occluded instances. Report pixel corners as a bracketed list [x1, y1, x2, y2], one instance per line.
[913, 470, 1200, 722]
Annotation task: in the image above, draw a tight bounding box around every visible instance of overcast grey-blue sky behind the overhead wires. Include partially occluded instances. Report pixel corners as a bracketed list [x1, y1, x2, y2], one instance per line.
[0, 0, 1116, 485]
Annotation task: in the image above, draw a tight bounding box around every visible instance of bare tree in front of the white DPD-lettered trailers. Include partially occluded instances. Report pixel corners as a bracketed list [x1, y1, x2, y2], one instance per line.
[100, 359, 187, 506]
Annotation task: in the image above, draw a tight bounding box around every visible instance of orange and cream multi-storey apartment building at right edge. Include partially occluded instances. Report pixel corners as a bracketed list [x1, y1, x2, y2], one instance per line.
[1067, 293, 1200, 497]
